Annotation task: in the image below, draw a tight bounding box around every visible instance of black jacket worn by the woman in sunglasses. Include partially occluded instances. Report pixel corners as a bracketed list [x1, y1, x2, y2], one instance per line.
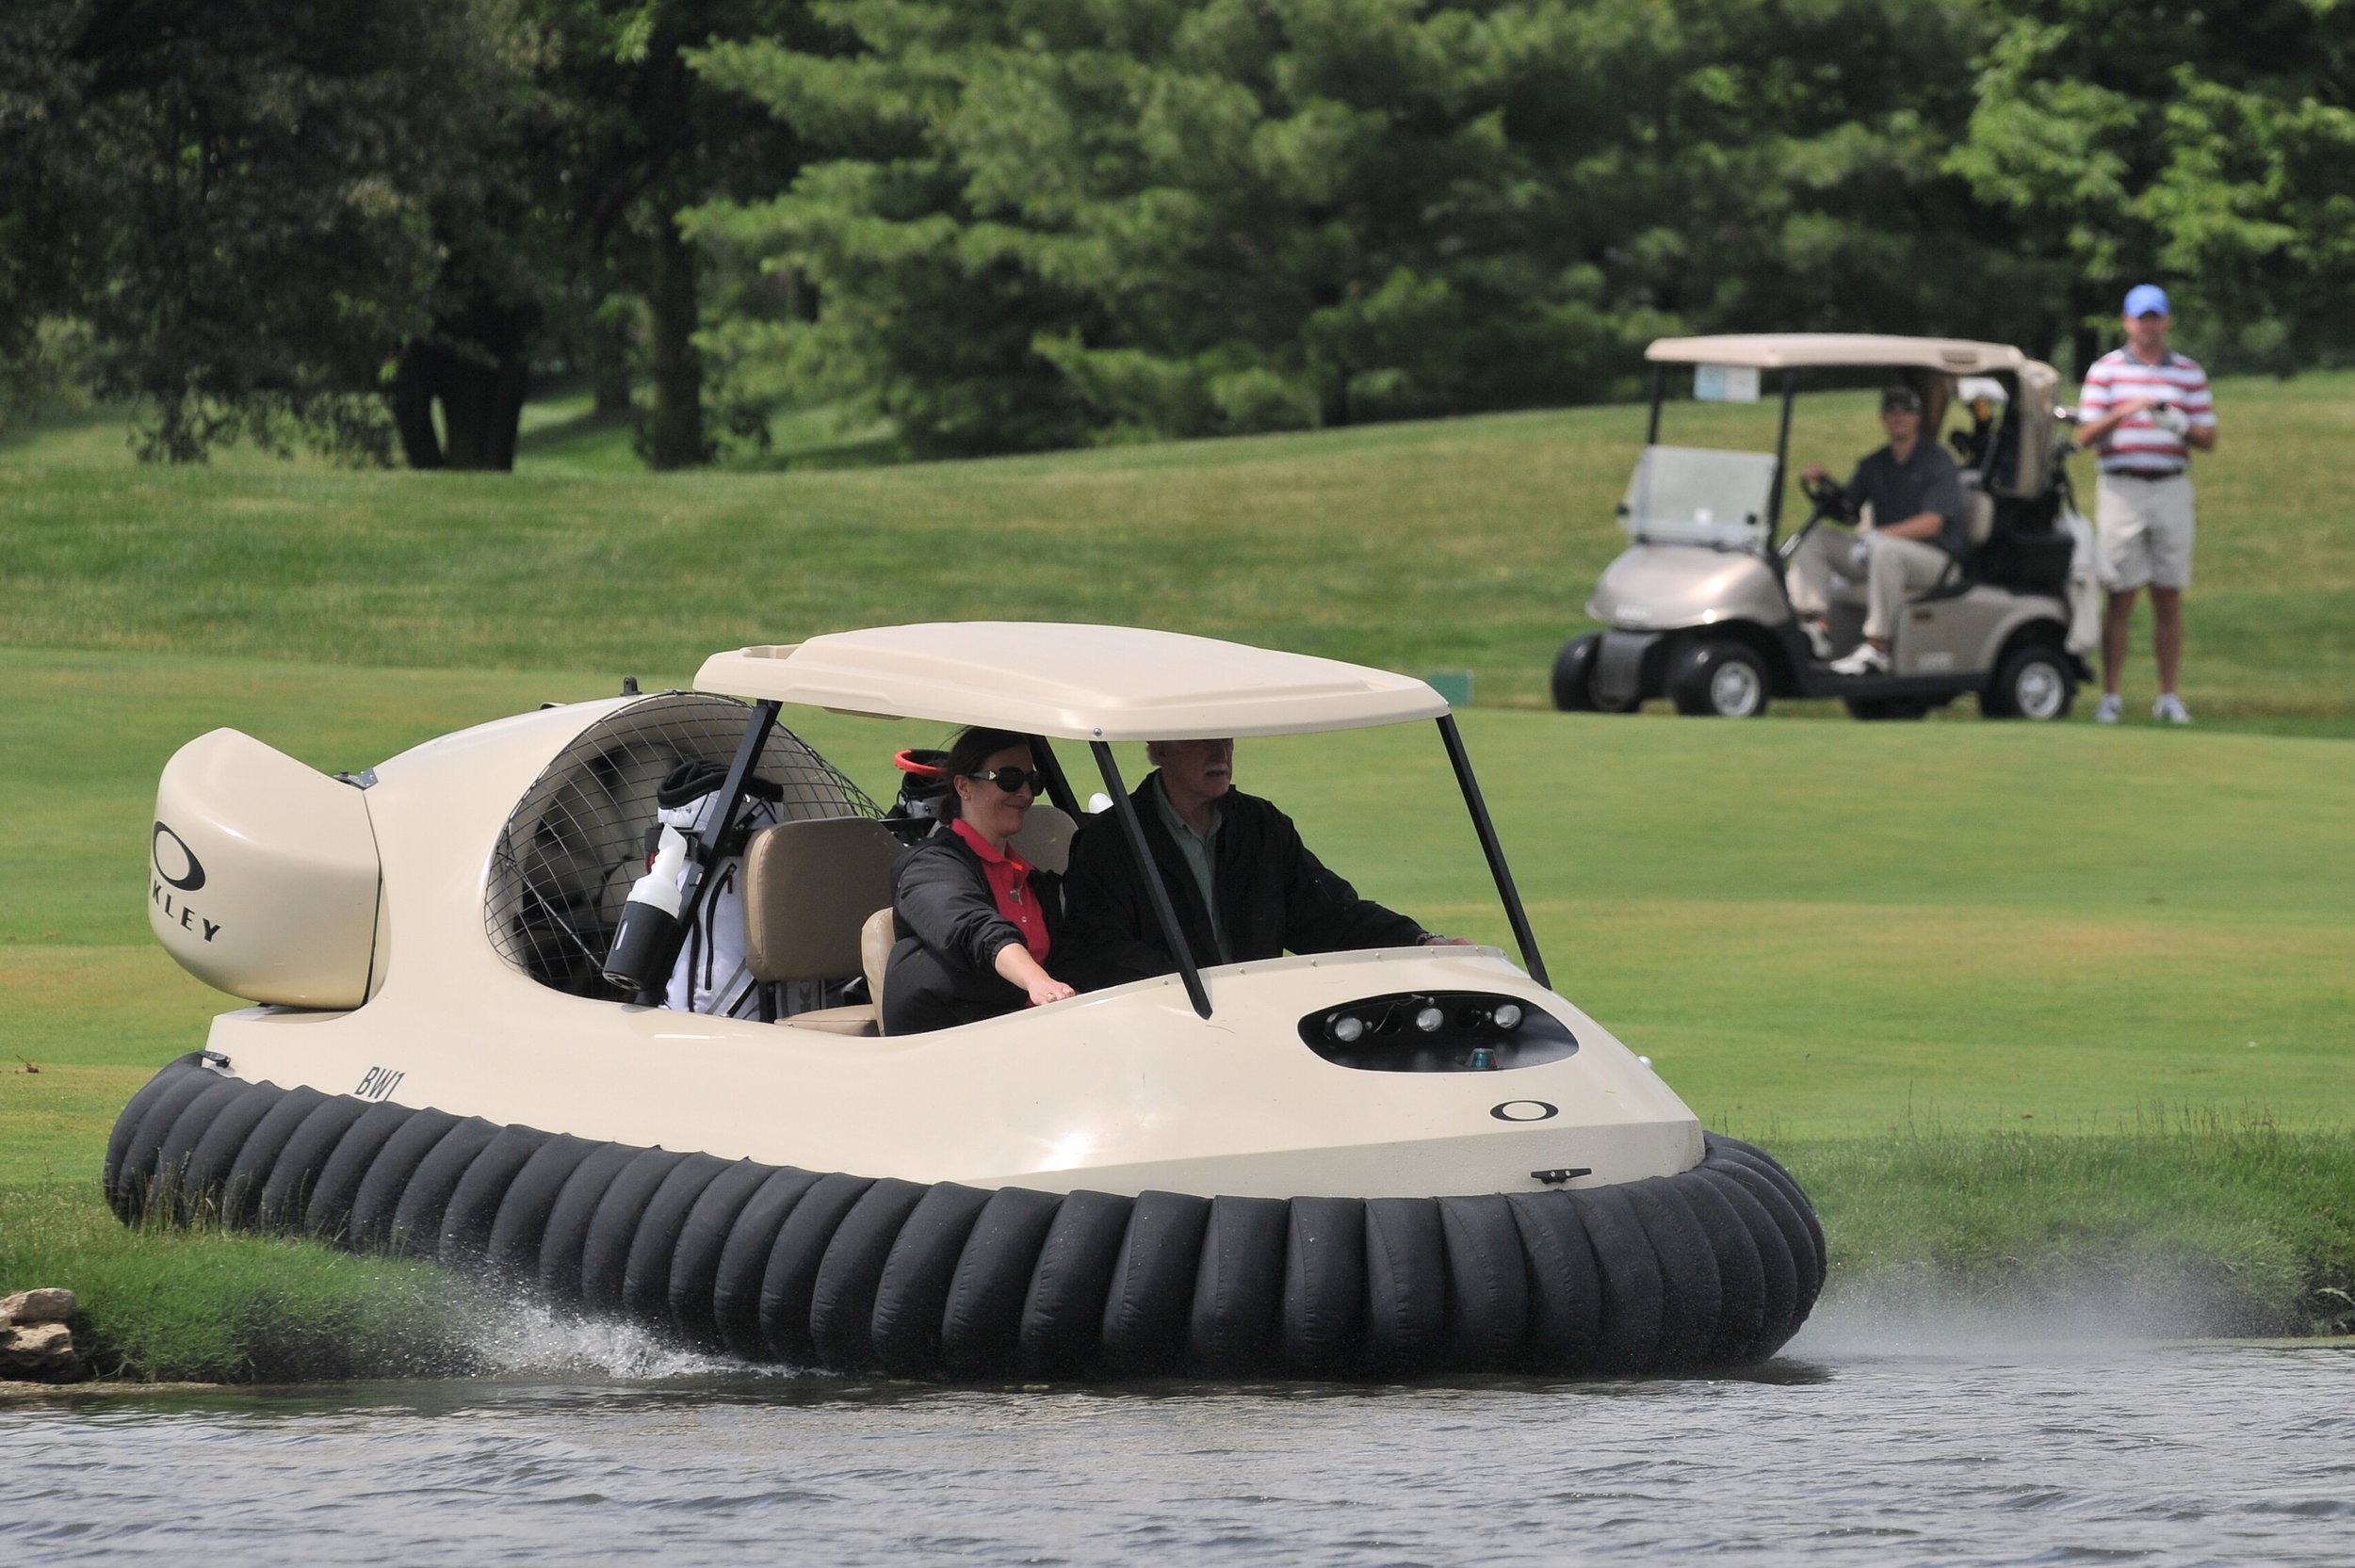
[884, 827, 1088, 1034]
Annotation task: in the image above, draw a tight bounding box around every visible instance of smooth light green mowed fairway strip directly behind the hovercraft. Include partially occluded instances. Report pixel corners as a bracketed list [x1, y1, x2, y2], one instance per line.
[0, 650, 2355, 1182]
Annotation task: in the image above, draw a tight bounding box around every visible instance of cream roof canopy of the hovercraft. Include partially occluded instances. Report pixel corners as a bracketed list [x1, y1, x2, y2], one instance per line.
[695, 622, 1449, 742]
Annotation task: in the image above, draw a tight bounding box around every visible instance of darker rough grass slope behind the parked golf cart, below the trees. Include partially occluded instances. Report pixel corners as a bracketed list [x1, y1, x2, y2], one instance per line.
[0, 375, 2355, 735]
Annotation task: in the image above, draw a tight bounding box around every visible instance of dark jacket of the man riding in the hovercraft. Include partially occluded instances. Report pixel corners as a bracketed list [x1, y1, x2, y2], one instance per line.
[1063, 772, 1422, 984]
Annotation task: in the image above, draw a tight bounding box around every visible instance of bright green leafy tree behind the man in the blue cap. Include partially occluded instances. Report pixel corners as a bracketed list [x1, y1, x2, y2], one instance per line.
[1950, 0, 2355, 370]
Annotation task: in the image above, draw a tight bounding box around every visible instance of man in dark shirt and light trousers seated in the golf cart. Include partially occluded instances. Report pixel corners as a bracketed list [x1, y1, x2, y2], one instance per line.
[1788, 386, 1967, 676]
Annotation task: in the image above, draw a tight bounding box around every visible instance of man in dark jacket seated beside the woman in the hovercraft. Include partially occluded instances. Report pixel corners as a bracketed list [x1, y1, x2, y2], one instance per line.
[1064, 739, 1468, 984]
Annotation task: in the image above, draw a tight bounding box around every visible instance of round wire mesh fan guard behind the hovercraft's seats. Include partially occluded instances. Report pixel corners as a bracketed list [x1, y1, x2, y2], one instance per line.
[483, 692, 884, 1001]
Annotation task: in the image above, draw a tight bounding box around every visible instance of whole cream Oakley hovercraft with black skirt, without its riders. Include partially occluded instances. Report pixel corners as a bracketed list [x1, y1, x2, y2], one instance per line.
[106, 624, 1826, 1375]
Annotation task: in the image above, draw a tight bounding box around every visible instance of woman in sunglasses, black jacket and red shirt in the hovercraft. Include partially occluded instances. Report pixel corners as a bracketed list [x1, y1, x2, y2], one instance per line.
[884, 728, 1072, 1034]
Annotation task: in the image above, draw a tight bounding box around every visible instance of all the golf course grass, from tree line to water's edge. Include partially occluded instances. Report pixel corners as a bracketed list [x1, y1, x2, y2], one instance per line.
[0, 377, 2355, 1378]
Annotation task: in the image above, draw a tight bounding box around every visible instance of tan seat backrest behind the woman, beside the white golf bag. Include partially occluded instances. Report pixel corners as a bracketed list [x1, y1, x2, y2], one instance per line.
[744, 817, 900, 982]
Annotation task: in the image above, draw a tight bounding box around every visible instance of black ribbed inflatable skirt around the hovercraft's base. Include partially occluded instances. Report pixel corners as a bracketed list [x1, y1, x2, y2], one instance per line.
[104, 1053, 1826, 1378]
